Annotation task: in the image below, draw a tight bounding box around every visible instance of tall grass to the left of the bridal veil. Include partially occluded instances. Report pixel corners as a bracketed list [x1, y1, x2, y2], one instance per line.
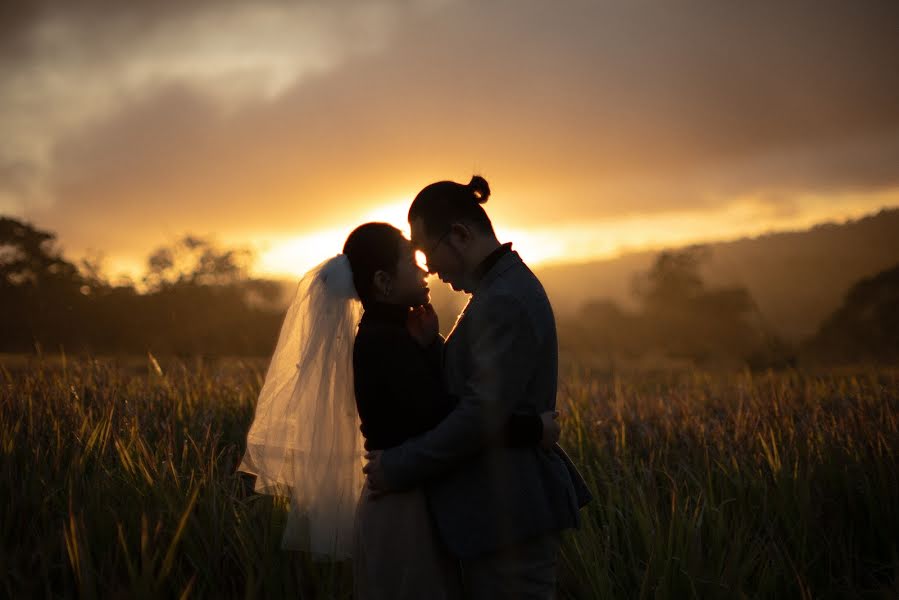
[0, 361, 352, 598]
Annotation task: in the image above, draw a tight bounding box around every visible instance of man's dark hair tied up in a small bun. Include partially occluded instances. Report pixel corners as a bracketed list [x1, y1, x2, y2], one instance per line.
[409, 175, 493, 237]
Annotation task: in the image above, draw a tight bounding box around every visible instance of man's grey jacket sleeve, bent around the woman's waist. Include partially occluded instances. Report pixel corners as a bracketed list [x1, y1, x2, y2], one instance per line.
[381, 296, 538, 489]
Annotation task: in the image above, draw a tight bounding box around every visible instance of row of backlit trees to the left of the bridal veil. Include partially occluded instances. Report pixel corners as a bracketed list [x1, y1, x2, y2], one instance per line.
[0, 217, 283, 356]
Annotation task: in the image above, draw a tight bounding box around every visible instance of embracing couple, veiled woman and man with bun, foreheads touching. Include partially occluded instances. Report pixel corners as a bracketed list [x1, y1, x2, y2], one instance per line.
[240, 176, 590, 600]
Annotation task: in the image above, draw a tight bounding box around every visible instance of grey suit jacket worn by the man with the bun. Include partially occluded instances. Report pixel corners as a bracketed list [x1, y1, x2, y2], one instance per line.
[381, 252, 589, 558]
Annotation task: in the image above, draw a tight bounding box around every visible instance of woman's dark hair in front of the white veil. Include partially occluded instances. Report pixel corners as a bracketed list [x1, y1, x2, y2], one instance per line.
[343, 223, 404, 306]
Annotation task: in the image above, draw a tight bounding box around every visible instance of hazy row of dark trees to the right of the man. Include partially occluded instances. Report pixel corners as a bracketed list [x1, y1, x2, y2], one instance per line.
[560, 246, 899, 369]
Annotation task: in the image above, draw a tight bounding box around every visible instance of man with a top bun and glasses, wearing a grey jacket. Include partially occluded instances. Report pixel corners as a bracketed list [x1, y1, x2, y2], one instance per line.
[365, 176, 590, 599]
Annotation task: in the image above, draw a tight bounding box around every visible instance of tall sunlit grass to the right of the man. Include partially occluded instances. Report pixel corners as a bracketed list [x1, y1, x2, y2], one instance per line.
[561, 370, 899, 598]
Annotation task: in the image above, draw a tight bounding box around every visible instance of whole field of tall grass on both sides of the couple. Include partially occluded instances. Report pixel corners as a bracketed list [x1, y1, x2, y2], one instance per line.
[0, 357, 899, 598]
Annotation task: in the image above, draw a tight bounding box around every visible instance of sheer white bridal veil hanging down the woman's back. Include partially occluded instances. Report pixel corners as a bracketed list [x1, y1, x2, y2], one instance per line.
[238, 254, 364, 558]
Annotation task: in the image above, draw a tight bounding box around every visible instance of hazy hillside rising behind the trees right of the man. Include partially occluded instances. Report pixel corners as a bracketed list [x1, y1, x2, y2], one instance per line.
[537, 208, 899, 340]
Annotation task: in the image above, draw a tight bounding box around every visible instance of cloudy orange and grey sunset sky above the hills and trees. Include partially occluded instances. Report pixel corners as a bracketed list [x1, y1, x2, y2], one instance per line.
[0, 0, 899, 274]
